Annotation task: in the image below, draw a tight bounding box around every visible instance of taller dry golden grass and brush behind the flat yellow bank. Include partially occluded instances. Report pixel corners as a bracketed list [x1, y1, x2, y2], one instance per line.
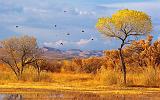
[0, 67, 160, 86]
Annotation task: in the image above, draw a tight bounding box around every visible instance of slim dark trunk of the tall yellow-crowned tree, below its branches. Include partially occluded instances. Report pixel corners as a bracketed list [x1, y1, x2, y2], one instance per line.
[119, 48, 127, 85]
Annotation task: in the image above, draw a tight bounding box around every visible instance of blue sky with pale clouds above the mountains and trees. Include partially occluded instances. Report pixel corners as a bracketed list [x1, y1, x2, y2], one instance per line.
[0, 0, 160, 50]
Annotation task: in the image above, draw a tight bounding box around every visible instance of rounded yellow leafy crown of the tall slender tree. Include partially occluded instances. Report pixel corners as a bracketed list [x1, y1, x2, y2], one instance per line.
[96, 9, 152, 38]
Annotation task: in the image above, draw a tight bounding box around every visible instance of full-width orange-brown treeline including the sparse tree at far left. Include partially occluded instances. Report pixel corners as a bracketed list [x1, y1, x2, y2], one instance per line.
[1, 36, 160, 84]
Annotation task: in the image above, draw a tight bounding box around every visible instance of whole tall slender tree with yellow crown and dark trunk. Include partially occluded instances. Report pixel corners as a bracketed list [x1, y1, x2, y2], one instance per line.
[96, 9, 152, 84]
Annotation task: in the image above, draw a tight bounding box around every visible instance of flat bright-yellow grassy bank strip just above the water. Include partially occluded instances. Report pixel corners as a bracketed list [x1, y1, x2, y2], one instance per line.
[0, 83, 160, 94]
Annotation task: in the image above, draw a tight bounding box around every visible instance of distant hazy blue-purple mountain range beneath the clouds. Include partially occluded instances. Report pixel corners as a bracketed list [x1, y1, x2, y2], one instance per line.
[43, 47, 103, 60]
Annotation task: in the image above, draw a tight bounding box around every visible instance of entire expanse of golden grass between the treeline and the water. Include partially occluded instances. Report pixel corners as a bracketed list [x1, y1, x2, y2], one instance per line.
[0, 65, 160, 94]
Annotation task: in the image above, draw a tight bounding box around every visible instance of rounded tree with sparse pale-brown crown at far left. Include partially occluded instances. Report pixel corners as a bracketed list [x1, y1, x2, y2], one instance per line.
[1, 36, 39, 80]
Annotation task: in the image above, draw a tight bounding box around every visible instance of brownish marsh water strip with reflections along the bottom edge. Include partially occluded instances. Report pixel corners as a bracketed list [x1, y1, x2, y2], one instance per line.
[0, 92, 160, 100]
